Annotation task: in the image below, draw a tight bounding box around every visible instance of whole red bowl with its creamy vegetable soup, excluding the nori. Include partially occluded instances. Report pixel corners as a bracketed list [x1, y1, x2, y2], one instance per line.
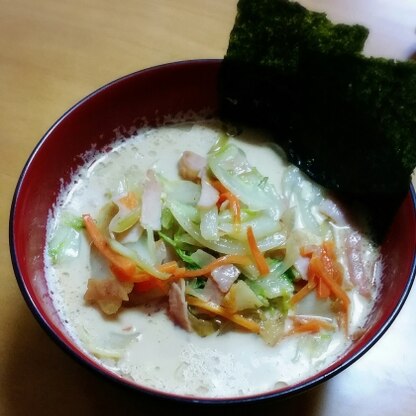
[10, 60, 416, 403]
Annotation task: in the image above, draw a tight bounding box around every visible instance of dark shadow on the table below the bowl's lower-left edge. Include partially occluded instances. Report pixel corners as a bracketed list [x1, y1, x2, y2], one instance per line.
[2, 304, 326, 416]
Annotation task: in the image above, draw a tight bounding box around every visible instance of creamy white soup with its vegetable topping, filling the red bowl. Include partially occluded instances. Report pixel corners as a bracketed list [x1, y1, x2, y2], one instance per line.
[45, 121, 378, 397]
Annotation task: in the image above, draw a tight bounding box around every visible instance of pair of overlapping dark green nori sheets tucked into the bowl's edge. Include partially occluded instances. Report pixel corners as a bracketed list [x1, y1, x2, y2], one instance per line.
[220, 0, 416, 237]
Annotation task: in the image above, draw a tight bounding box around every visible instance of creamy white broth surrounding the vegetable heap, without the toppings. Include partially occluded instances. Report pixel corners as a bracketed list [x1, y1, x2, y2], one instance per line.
[45, 118, 377, 397]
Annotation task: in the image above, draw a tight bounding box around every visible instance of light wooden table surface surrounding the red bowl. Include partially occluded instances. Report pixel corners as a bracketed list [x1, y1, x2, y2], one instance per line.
[0, 0, 416, 416]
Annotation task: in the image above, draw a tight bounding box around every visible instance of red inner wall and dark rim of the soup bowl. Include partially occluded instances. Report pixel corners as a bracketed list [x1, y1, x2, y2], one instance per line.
[9, 60, 416, 403]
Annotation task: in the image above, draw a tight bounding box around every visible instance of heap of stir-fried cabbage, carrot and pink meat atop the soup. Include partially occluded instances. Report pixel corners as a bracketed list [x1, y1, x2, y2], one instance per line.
[55, 135, 374, 345]
